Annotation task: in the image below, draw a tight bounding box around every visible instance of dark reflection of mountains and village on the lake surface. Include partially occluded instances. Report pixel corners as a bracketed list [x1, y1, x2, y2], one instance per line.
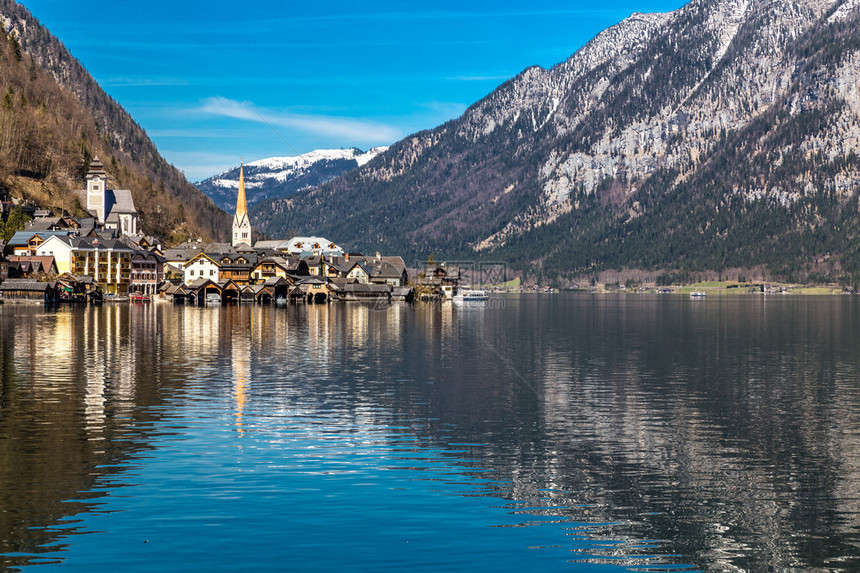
[0, 295, 860, 571]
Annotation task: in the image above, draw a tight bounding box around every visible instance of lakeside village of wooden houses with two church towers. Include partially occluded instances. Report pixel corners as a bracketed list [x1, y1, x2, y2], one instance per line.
[0, 157, 446, 304]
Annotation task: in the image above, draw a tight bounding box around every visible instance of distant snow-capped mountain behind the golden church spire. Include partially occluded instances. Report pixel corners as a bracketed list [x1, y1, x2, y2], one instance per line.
[196, 147, 388, 213]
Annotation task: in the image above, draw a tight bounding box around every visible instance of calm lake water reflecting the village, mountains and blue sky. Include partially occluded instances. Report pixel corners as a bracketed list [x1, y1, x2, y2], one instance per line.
[0, 295, 860, 571]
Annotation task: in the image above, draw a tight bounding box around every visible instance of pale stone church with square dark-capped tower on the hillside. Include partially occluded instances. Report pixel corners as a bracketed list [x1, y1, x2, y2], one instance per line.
[78, 157, 138, 235]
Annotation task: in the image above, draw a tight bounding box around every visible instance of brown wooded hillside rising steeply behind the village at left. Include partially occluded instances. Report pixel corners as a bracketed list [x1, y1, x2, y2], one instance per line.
[0, 0, 230, 243]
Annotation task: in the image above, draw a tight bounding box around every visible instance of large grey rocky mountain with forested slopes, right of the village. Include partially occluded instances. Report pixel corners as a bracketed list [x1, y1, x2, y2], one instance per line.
[254, 0, 860, 280]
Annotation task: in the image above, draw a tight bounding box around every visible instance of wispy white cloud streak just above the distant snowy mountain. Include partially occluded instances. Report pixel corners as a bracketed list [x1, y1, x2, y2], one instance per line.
[197, 96, 403, 145]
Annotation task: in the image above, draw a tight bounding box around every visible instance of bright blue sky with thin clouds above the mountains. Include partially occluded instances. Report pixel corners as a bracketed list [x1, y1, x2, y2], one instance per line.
[23, 0, 684, 181]
